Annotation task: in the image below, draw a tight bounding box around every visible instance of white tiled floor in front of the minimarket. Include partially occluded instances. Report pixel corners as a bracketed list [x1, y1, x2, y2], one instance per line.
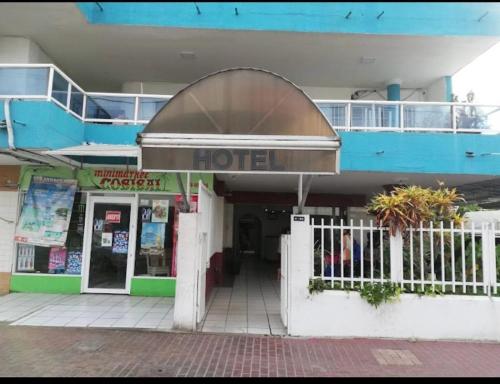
[0, 293, 174, 330]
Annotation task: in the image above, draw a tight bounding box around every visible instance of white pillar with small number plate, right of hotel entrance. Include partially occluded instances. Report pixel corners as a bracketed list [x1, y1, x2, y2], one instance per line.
[288, 215, 313, 335]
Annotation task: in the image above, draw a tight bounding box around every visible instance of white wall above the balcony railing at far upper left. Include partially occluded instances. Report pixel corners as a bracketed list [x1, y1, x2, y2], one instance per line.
[0, 36, 53, 64]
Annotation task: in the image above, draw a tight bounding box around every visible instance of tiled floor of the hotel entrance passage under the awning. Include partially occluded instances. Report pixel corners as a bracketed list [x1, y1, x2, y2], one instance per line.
[199, 257, 286, 335]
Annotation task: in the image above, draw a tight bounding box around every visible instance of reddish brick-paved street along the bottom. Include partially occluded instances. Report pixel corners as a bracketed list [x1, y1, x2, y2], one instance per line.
[0, 324, 500, 377]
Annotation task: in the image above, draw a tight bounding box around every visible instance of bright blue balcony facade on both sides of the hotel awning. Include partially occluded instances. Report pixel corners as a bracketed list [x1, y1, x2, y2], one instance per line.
[0, 101, 500, 175]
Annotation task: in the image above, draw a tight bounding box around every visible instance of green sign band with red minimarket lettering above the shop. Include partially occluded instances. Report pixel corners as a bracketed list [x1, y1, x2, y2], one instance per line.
[19, 166, 213, 193]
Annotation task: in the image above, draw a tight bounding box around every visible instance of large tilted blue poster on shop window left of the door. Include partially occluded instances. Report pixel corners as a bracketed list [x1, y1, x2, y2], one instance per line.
[15, 176, 77, 247]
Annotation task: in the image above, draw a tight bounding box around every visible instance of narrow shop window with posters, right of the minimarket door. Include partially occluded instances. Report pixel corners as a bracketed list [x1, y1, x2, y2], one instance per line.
[134, 195, 175, 276]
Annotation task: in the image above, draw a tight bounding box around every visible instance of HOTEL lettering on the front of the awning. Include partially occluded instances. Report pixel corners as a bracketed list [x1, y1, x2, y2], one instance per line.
[193, 149, 285, 172]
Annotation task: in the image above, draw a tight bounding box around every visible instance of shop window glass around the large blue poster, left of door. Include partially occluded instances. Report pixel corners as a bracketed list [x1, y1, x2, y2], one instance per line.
[16, 192, 86, 275]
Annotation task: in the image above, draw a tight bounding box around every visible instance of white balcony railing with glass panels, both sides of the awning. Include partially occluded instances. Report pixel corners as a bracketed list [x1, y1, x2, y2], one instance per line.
[0, 64, 500, 134]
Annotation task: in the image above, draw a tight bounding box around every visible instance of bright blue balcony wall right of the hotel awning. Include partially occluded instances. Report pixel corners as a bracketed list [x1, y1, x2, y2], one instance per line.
[340, 132, 500, 175]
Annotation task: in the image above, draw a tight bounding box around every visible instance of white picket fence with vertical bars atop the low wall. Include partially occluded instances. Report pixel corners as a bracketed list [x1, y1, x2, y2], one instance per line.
[310, 219, 500, 295]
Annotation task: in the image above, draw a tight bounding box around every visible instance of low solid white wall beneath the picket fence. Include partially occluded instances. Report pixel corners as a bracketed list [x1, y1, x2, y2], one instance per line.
[289, 291, 500, 341]
